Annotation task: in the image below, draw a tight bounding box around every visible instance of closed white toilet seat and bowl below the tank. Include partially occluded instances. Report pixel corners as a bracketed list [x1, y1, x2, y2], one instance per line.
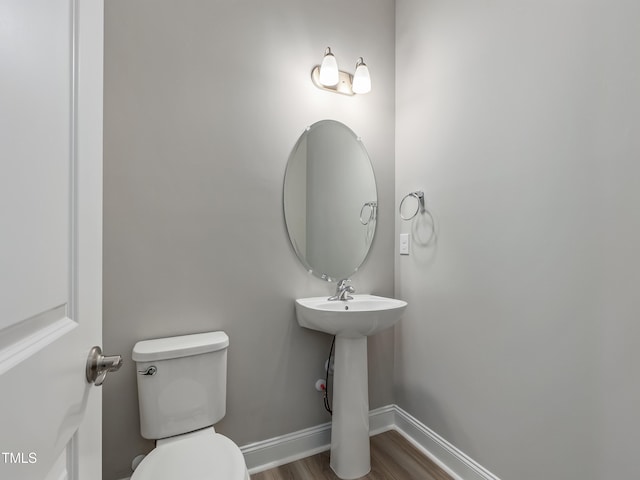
[131, 428, 249, 480]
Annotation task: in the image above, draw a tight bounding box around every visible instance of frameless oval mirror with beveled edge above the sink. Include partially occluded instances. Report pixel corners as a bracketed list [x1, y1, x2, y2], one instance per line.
[284, 120, 378, 281]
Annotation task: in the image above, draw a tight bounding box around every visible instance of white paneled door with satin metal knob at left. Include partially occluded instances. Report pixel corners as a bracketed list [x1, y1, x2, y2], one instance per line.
[0, 0, 108, 480]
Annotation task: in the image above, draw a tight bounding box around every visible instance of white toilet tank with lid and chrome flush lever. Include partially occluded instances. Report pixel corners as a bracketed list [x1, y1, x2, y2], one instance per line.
[132, 332, 229, 439]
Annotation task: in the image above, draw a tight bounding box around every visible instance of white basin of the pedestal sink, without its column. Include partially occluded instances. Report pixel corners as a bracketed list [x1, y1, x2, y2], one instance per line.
[296, 295, 407, 338]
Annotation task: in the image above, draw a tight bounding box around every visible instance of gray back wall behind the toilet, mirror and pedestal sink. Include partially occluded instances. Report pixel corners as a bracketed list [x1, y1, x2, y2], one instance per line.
[103, 0, 395, 480]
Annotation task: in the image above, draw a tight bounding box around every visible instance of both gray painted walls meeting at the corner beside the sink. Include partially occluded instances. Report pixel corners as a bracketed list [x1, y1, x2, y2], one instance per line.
[103, 0, 640, 480]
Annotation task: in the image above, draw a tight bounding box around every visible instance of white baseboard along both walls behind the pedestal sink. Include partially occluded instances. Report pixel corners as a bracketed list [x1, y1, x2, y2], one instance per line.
[240, 405, 500, 480]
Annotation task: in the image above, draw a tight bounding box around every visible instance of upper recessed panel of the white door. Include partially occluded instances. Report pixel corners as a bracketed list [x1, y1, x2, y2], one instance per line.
[0, 0, 74, 328]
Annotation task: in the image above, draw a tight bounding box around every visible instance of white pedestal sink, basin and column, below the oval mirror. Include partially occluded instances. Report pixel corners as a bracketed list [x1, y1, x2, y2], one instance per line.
[296, 295, 407, 479]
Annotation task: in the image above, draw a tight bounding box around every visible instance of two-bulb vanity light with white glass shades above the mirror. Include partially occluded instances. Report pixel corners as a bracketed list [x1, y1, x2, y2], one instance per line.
[311, 47, 371, 95]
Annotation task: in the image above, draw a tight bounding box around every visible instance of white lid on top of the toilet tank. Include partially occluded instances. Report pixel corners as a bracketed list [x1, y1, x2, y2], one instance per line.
[132, 332, 229, 362]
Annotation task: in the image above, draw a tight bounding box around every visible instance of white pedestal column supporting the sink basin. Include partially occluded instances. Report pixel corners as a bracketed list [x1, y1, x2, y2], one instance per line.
[331, 336, 371, 479]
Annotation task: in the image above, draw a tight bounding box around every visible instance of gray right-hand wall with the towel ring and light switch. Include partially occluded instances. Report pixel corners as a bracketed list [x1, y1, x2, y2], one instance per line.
[395, 0, 640, 480]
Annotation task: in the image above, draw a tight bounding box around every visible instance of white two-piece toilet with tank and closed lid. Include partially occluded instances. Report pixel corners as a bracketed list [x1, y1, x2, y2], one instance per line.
[131, 332, 249, 480]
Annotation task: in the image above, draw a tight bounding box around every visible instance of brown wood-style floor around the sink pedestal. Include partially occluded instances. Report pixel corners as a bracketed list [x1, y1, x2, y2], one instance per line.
[251, 430, 452, 480]
